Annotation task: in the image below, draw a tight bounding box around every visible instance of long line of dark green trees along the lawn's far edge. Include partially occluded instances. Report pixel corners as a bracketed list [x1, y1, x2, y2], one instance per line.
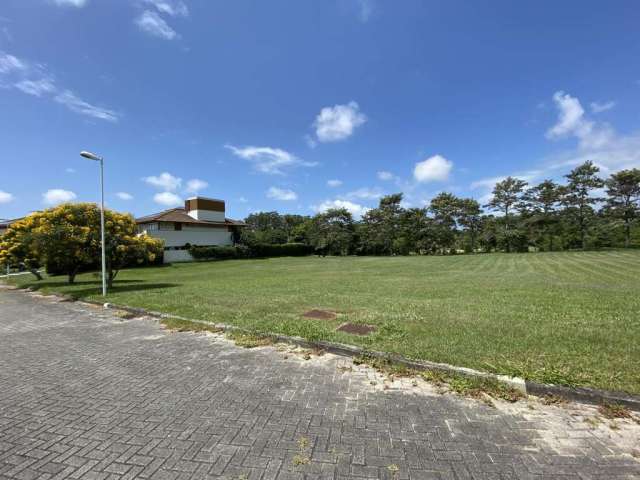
[240, 161, 640, 255]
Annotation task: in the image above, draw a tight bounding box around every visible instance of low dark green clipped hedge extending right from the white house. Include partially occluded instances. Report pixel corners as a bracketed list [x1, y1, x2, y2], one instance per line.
[189, 243, 313, 260]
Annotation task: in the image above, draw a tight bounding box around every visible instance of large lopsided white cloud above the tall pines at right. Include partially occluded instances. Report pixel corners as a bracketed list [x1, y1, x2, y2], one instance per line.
[547, 91, 614, 149]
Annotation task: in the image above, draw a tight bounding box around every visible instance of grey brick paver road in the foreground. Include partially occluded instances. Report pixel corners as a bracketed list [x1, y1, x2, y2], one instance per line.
[0, 290, 640, 479]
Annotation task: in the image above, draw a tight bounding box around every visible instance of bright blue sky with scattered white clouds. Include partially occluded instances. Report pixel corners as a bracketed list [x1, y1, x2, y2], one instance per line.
[0, 0, 640, 218]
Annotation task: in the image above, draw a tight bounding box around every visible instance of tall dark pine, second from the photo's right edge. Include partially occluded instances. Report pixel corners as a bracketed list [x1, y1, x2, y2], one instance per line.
[562, 161, 604, 250]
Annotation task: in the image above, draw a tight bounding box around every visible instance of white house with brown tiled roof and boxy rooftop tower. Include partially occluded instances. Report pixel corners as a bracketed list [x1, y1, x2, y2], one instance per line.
[136, 197, 245, 263]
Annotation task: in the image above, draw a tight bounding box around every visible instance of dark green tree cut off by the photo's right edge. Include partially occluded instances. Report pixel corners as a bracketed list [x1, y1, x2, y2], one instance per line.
[606, 168, 640, 248]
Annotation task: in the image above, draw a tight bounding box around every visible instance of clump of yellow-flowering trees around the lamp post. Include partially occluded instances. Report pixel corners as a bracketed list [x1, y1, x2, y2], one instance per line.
[0, 203, 163, 285]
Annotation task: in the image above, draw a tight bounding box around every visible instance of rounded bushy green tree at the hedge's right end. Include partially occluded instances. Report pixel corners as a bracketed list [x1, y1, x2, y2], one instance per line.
[309, 208, 355, 255]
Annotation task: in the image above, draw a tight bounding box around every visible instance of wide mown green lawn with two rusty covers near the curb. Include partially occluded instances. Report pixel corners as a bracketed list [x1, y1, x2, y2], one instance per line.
[8, 251, 640, 393]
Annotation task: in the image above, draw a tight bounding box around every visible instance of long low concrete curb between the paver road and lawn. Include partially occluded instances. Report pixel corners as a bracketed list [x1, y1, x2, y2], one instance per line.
[87, 294, 640, 412]
